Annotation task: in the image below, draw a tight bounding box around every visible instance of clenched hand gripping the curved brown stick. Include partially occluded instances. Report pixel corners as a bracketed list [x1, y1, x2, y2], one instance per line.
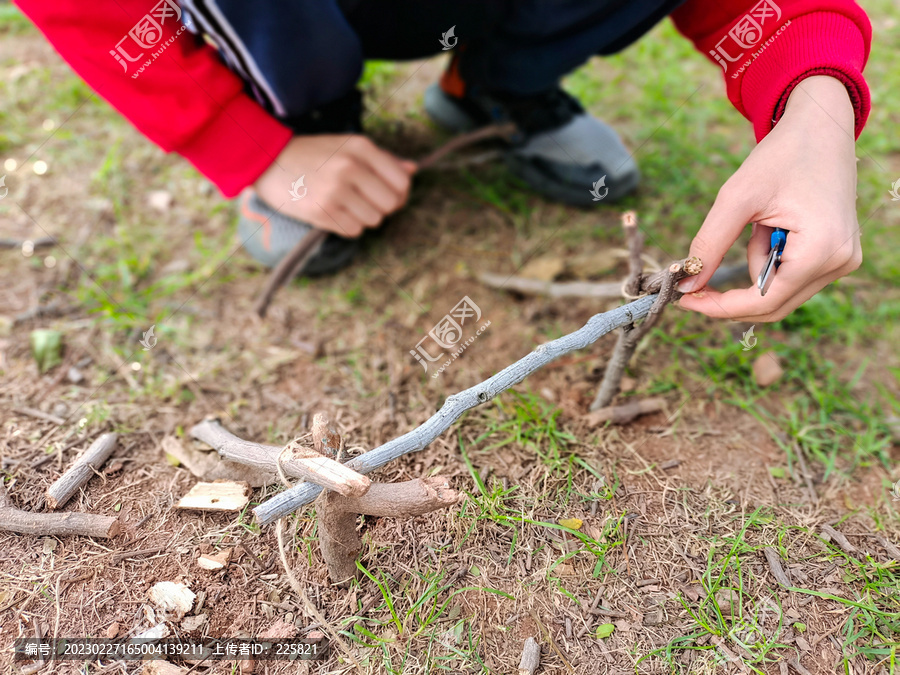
[253, 134, 416, 237]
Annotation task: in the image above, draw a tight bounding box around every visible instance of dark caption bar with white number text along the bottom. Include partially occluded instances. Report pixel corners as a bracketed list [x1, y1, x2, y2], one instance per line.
[13, 638, 328, 661]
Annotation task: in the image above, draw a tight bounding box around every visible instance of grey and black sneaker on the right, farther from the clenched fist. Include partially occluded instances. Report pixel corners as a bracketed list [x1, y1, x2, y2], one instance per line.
[425, 84, 640, 206]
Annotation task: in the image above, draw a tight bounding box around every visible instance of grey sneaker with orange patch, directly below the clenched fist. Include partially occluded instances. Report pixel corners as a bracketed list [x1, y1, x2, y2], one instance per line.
[238, 190, 359, 276]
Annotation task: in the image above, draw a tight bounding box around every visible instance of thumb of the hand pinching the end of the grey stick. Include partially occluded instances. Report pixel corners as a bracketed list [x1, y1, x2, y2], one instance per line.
[678, 184, 755, 293]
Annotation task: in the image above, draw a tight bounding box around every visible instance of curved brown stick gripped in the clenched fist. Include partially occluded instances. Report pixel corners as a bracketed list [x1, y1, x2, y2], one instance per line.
[253, 123, 516, 318]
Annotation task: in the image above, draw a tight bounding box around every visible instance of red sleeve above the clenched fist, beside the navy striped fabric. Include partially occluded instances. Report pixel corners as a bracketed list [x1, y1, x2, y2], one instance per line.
[16, 0, 291, 197]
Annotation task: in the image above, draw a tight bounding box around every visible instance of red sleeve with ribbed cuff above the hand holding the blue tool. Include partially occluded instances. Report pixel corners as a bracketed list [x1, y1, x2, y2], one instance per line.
[672, 0, 872, 140]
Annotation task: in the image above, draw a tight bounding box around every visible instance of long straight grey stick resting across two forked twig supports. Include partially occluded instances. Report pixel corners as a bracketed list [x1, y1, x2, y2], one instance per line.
[253, 295, 656, 525]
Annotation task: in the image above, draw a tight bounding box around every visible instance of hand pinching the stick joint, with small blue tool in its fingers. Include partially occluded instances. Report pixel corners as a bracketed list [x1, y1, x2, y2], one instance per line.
[679, 76, 862, 321]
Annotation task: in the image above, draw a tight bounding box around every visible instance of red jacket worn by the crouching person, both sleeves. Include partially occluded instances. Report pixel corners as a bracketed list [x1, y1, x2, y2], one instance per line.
[16, 0, 872, 197]
